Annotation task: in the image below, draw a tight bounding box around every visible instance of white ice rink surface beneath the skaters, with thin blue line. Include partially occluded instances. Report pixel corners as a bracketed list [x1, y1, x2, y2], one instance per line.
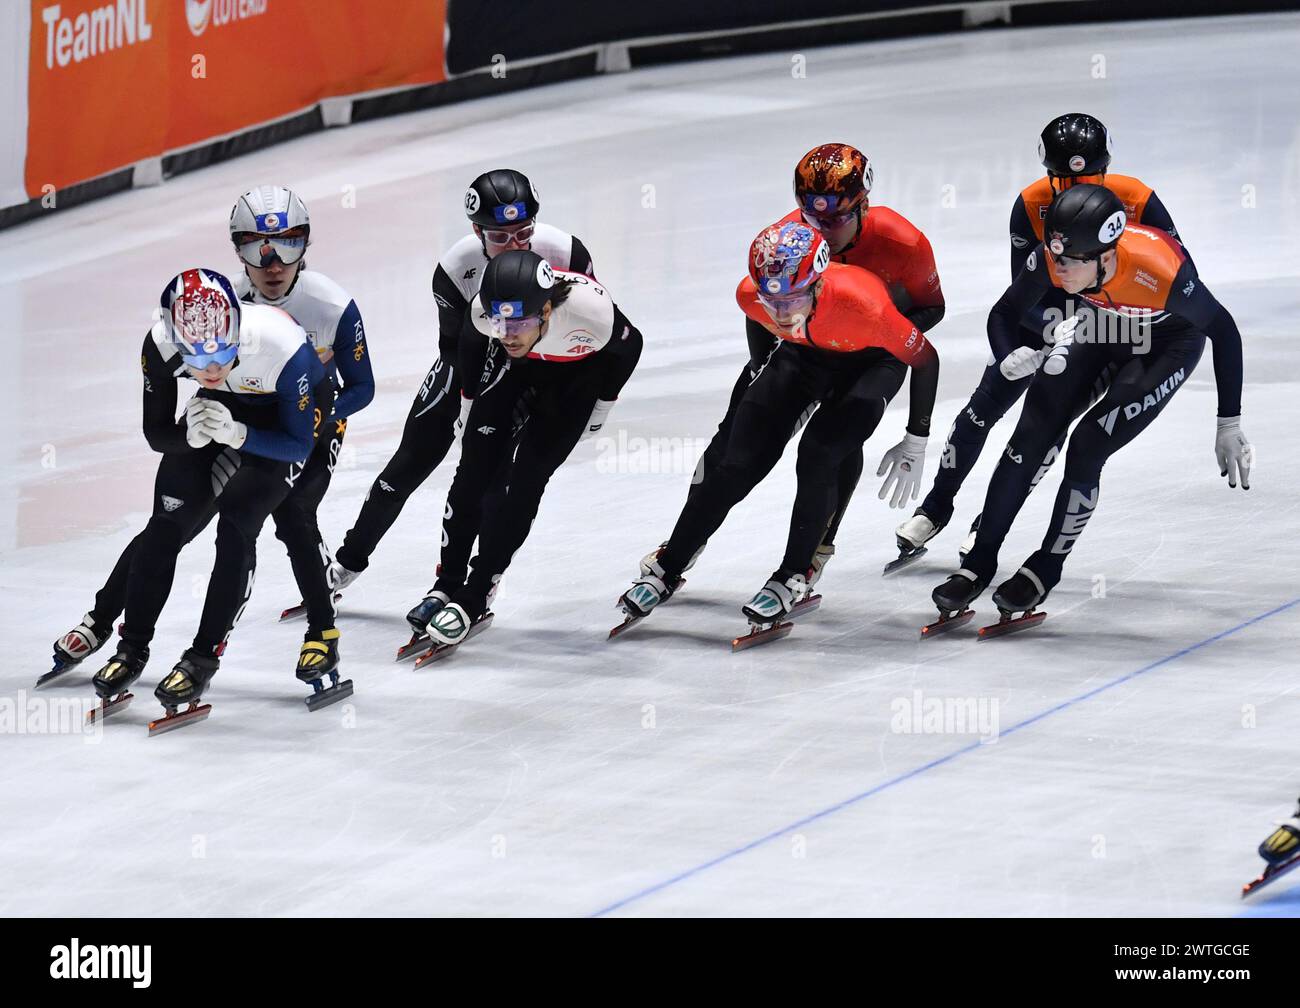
[0, 16, 1300, 916]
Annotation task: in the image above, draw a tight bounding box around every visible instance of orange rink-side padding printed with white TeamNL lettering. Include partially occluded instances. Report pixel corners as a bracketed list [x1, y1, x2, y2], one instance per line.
[25, 0, 446, 196]
